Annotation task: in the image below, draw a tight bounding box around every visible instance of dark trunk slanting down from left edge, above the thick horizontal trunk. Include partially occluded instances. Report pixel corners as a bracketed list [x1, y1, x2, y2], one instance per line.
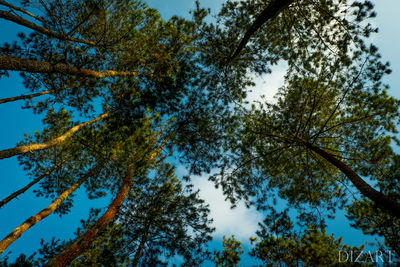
[0, 10, 96, 46]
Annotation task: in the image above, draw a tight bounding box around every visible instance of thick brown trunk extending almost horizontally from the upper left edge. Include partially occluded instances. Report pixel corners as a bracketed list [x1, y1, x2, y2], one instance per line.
[0, 56, 138, 78]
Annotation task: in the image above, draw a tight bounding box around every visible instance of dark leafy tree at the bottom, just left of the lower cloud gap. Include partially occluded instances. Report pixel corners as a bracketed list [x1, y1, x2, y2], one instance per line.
[117, 163, 214, 266]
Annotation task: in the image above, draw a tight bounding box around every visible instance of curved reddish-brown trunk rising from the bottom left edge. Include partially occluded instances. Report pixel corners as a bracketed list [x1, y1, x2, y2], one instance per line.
[45, 138, 168, 267]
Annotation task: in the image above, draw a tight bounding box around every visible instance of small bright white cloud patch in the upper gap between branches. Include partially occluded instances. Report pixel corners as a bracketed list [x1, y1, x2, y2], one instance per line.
[246, 62, 287, 104]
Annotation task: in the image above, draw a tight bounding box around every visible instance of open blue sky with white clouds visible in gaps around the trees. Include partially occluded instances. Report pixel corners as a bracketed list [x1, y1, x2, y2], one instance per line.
[0, 0, 400, 266]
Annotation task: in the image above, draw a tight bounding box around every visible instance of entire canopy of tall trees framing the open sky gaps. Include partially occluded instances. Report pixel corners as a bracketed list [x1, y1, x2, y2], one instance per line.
[0, 0, 400, 266]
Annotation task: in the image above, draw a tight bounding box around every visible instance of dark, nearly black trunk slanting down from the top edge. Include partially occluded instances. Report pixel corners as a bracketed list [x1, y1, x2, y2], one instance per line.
[230, 0, 294, 60]
